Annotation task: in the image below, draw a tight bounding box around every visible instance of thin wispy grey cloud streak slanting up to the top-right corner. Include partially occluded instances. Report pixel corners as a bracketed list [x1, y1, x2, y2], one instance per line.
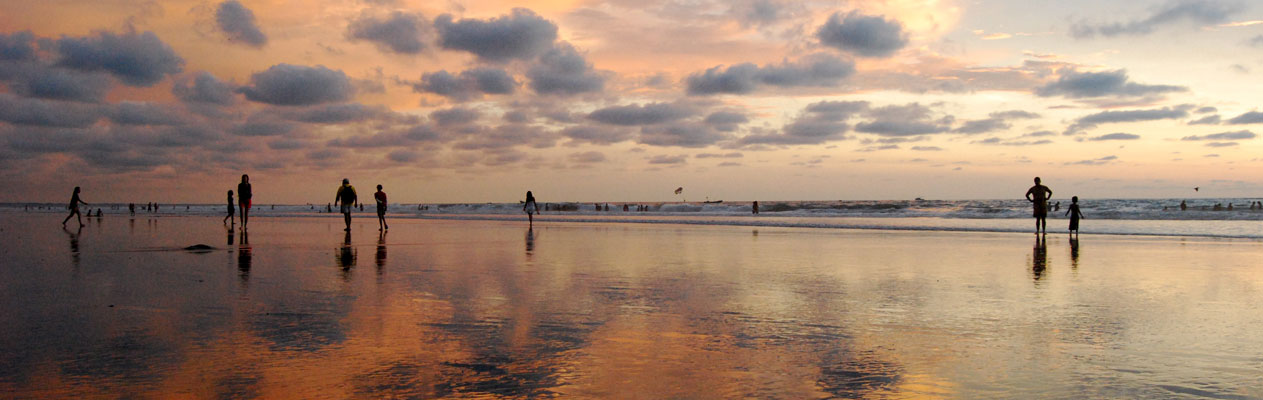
[1070, 0, 1242, 39]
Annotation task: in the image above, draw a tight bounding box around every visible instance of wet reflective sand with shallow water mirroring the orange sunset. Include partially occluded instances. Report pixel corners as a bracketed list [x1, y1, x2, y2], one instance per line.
[0, 215, 1263, 399]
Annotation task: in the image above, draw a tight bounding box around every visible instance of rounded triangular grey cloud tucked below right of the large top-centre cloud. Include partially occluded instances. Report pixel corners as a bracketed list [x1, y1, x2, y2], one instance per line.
[527, 43, 605, 96]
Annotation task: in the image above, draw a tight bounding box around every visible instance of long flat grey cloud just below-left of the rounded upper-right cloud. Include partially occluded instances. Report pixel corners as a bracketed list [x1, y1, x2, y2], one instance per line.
[685, 54, 855, 95]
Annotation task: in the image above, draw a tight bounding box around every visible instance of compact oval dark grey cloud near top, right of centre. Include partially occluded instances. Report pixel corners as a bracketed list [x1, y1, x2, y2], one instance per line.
[816, 11, 908, 57]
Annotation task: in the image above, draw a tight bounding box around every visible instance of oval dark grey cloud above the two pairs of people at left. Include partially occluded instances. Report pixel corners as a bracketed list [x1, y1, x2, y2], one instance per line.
[236, 64, 355, 106]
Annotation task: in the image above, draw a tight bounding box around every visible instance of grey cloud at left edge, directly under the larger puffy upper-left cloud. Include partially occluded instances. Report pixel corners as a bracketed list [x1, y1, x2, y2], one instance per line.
[0, 63, 110, 102]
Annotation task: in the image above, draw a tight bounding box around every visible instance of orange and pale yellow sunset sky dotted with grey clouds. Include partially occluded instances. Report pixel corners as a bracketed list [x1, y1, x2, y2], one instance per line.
[0, 0, 1263, 200]
